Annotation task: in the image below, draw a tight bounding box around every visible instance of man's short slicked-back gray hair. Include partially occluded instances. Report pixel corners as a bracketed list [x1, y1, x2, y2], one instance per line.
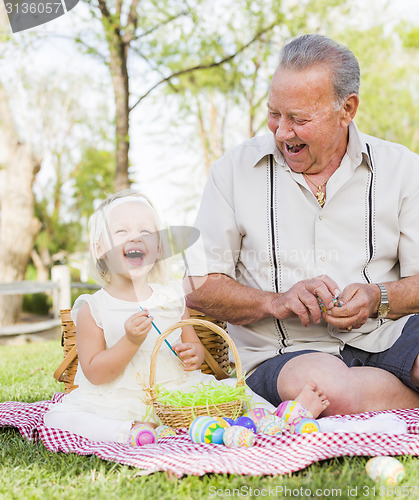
[279, 35, 360, 103]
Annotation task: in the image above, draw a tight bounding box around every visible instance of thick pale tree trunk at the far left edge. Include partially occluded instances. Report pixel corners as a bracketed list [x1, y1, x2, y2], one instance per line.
[0, 87, 41, 326]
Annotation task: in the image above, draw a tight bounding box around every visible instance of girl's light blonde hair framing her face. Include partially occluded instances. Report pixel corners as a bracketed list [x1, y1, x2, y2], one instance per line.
[89, 189, 167, 286]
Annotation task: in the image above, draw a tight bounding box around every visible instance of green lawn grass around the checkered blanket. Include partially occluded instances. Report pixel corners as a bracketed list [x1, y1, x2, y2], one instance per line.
[0, 341, 419, 500]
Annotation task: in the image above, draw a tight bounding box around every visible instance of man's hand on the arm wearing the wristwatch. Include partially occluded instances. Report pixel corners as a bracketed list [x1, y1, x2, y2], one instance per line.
[323, 283, 380, 331]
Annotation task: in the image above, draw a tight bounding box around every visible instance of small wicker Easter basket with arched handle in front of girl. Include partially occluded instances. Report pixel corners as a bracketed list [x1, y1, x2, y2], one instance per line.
[146, 318, 244, 428]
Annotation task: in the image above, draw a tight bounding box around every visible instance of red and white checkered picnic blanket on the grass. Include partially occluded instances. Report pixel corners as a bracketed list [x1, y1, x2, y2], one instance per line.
[0, 393, 419, 477]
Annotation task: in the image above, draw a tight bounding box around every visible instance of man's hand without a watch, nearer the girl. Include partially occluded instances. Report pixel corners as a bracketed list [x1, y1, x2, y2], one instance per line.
[271, 275, 339, 327]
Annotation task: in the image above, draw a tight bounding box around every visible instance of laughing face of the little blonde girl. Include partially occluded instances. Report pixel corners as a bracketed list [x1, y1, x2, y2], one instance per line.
[101, 201, 159, 279]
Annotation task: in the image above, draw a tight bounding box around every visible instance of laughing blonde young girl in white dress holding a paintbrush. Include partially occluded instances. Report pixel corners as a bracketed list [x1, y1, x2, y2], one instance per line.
[44, 190, 325, 442]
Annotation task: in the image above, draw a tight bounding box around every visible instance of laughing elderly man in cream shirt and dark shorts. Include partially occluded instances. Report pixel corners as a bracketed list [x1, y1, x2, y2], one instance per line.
[185, 35, 419, 415]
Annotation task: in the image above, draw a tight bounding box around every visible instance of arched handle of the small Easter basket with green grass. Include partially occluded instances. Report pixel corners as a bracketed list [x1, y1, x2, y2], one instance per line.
[149, 318, 244, 399]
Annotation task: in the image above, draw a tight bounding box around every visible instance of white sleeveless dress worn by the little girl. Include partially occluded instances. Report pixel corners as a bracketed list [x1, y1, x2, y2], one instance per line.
[44, 283, 273, 442]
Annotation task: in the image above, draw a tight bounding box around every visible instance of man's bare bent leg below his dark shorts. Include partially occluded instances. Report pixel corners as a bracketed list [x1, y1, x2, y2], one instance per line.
[277, 353, 419, 417]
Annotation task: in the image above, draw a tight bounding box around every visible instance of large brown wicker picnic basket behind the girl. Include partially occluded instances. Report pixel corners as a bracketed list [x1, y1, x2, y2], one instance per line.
[54, 309, 230, 393]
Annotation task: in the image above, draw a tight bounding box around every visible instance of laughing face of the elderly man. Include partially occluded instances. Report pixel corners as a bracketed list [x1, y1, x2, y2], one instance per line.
[268, 65, 349, 174]
